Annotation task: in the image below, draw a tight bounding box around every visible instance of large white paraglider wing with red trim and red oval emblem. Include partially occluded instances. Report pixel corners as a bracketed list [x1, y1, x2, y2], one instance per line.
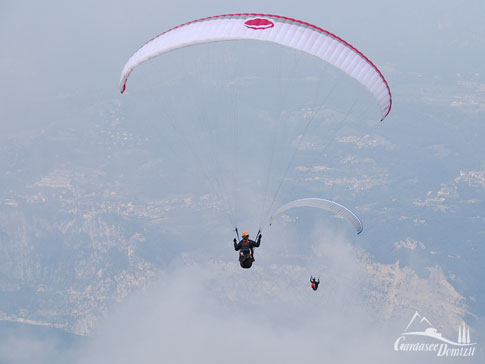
[120, 14, 392, 121]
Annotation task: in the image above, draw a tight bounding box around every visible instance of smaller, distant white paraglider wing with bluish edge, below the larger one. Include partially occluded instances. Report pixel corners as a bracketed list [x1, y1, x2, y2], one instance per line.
[270, 198, 364, 234]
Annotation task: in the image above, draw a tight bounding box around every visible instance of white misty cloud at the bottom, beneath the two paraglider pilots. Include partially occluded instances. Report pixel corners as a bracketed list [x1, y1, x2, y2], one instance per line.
[75, 228, 466, 363]
